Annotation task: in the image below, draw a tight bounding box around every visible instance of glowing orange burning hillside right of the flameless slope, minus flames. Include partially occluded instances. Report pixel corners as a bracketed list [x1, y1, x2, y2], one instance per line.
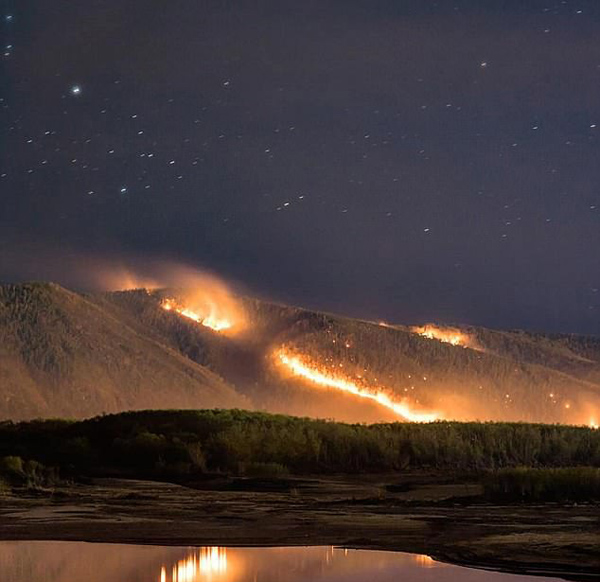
[98, 291, 600, 424]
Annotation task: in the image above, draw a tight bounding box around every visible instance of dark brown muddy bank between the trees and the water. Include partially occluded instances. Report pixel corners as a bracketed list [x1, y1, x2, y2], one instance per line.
[0, 476, 600, 580]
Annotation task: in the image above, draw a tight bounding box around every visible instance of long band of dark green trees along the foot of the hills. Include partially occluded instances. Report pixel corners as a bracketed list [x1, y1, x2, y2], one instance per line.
[0, 410, 600, 477]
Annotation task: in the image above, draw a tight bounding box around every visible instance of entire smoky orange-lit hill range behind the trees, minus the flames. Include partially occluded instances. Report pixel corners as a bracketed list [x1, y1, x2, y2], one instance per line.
[0, 284, 600, 424]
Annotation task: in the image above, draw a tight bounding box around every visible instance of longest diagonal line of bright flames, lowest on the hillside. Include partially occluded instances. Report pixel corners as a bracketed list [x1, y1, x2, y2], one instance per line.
[277, 348, 440, 422]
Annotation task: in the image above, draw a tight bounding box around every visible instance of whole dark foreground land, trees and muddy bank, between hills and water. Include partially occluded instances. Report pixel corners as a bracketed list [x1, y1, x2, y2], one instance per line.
[0, 410, 600, 580]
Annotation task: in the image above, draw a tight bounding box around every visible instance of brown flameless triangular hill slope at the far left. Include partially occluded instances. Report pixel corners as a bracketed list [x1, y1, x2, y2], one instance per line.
[0, 283, 249, 419]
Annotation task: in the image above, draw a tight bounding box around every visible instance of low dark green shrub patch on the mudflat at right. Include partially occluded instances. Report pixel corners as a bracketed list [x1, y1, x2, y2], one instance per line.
[484, 467, 600, 502]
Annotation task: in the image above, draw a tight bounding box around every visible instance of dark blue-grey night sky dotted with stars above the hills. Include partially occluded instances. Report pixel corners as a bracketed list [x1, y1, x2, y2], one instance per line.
[0, 0, 600, 333]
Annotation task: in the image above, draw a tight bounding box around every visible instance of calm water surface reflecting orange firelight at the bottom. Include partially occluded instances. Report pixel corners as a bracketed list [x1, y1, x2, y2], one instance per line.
[0, 542, 557, 582]
